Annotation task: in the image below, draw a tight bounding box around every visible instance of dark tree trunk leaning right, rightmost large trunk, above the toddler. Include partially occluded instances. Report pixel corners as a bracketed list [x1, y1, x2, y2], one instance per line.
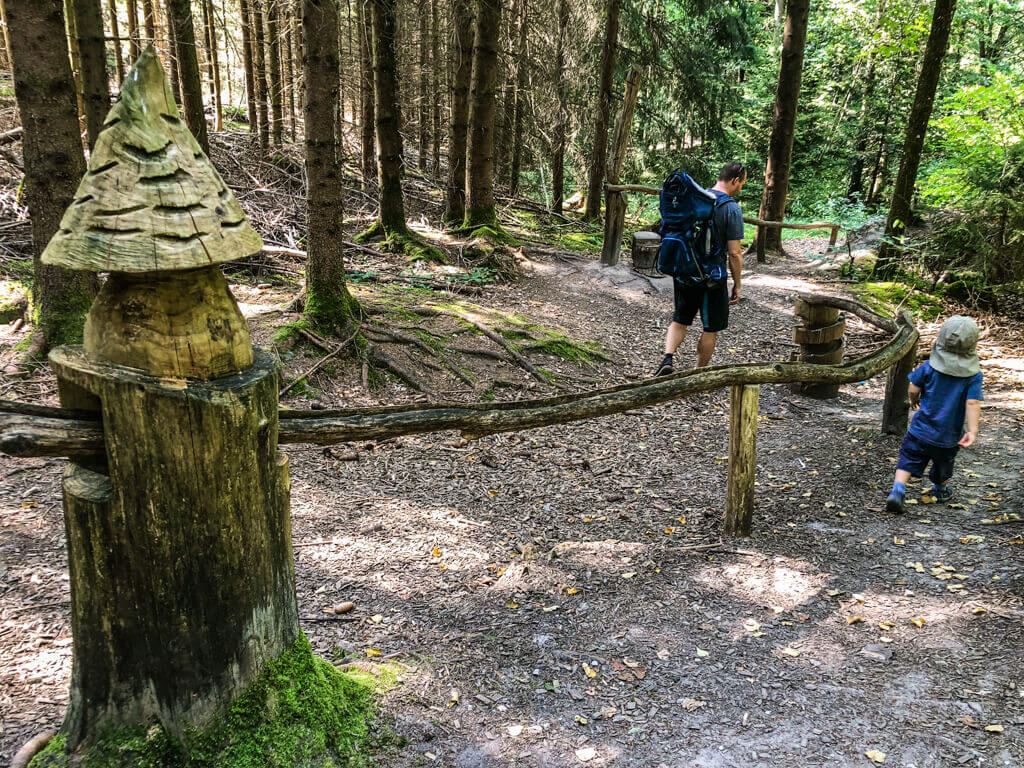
[872, 0, 956, 278]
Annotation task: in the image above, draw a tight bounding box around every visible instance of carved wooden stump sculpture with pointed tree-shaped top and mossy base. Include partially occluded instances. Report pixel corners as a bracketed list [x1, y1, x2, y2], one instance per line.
[33, 47, 370, 766]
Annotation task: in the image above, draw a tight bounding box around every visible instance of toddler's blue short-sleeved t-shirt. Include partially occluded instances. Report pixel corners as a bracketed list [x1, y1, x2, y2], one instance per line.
[907, 360, 984, 447]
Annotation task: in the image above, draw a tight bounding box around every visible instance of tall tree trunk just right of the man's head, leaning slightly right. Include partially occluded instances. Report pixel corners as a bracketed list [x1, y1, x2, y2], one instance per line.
[755, 0, 810, 261]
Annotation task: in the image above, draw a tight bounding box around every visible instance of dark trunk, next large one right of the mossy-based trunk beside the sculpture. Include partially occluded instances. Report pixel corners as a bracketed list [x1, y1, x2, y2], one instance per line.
[371, 0, 406, 236]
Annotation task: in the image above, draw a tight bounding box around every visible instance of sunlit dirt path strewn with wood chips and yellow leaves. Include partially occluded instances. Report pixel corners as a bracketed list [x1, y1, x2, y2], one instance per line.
[0, 239, 1024, 768]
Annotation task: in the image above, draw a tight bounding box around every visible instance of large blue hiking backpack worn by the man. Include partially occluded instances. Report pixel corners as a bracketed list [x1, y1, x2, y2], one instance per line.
[657, 169, 732, 286]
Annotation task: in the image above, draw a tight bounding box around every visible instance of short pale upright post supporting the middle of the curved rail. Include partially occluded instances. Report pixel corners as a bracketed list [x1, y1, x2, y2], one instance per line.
[722, 384, 761, 536]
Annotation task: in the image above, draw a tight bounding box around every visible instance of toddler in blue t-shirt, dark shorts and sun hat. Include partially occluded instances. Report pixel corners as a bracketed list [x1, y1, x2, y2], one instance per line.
[886, 314, 983, 514]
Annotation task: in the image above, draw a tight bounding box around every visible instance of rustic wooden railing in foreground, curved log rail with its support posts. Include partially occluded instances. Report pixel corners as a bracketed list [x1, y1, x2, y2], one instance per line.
[0, 294, 919, 535]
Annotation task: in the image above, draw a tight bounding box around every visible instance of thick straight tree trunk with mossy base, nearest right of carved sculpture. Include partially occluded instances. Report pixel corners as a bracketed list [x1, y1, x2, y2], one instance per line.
[302, 0, 355, 333]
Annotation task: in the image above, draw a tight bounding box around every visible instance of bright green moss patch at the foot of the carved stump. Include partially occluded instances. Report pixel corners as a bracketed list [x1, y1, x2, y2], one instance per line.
[30, 636, 385, 768]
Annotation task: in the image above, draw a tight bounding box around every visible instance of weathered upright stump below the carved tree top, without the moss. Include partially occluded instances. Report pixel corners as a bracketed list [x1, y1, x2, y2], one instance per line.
[51, 347, 300, 749]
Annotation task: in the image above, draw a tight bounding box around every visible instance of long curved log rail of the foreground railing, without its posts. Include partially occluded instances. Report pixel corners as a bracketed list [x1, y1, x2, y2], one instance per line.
[0, 295, 919, 457]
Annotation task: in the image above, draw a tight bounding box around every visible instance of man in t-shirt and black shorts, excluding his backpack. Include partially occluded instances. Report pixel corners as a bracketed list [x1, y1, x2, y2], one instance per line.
[654, 163, 746, 376]
